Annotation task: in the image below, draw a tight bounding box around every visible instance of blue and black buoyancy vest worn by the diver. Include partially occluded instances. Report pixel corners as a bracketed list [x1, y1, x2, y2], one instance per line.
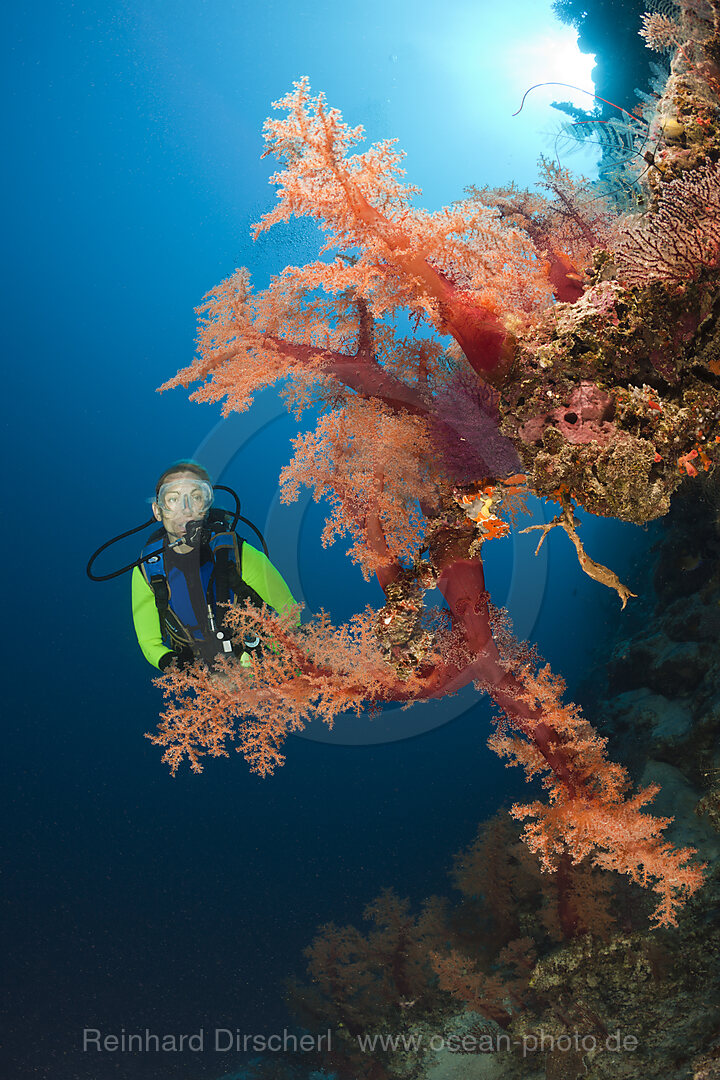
[140, 512, 262, 660]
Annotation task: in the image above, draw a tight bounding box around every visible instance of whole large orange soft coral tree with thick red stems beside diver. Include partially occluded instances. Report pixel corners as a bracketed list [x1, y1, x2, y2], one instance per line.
[147, 80, 716, 933]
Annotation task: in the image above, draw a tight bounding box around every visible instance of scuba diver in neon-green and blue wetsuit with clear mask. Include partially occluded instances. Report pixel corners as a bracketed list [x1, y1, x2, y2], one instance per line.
[87, 461, 295, 671]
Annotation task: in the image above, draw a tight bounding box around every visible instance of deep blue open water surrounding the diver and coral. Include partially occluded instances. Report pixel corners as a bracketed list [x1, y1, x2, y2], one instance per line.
[3, 0, 647, 1080]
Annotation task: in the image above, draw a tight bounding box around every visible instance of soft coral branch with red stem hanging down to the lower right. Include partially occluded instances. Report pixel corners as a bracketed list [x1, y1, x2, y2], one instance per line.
[425, 537, 704, 926]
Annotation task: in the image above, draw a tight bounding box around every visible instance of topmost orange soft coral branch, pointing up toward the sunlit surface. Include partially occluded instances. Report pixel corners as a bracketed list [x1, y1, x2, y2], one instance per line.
[250, 79, 548, 379]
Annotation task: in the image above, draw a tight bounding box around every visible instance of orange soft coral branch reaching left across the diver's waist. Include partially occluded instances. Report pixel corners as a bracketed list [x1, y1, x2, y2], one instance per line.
[148, 603, 455, 775]
